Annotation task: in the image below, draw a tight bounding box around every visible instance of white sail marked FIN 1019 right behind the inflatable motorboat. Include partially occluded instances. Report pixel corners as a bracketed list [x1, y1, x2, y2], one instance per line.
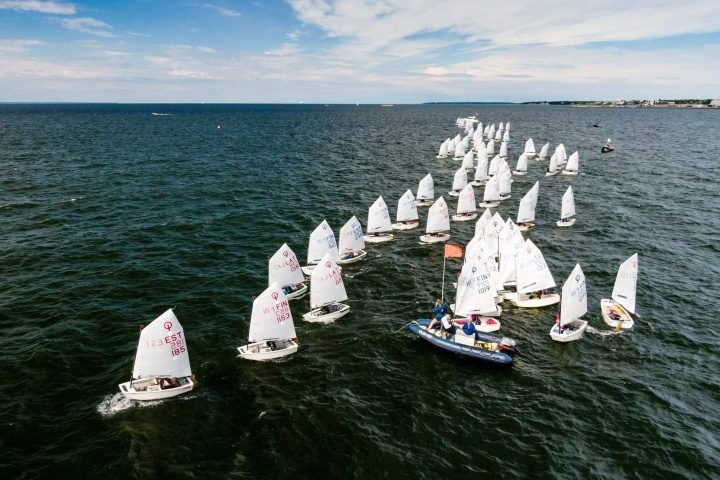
[454, 258, 497, 316]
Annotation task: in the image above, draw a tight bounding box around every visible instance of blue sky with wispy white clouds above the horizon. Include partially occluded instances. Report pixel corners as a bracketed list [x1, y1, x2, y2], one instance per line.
[0, 0, 720, 103]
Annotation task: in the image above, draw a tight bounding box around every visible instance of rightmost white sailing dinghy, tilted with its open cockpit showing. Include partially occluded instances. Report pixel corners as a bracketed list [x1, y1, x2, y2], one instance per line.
[600, 253, 638, 330]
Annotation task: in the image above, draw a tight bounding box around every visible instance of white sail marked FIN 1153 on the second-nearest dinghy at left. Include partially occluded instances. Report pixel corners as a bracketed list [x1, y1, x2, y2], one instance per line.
[248, 284, 298, 342]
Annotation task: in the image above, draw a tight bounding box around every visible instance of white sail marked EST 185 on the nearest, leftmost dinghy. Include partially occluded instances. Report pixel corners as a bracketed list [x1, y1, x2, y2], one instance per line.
[133, 309, 192, 379]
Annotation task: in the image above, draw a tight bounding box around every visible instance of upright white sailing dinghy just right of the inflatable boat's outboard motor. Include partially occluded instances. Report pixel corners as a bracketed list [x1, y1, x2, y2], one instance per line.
[550, 263, 587, 342]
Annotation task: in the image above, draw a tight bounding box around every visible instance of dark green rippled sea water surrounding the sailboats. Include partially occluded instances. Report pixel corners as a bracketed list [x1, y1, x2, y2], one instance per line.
[0, 105, 720, 479]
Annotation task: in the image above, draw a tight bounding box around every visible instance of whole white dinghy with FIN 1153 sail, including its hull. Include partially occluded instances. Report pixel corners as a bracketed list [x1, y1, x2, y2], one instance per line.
[238, 284, 298, 360]
